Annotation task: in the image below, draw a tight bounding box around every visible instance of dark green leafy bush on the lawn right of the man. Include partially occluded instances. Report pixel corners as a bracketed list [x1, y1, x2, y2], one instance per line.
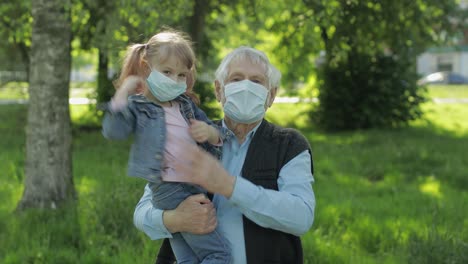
[312, 51, 425, 130]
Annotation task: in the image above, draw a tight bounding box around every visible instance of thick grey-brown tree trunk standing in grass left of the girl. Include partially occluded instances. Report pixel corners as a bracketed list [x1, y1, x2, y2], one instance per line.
[17, 0, 75, 210]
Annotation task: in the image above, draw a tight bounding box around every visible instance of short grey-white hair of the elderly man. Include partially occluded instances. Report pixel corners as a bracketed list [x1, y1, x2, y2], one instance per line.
[215, 46, 281, 89]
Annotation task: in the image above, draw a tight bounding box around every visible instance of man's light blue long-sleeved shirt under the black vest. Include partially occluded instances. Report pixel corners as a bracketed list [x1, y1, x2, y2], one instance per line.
[134, 121, 315, 264]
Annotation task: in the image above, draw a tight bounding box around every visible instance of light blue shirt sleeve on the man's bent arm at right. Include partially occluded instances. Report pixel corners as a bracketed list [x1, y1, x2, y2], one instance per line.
[230, 151, 315, 236]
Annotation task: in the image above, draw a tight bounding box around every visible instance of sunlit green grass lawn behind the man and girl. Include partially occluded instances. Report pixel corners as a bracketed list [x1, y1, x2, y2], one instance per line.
[0, 98, 468, 263]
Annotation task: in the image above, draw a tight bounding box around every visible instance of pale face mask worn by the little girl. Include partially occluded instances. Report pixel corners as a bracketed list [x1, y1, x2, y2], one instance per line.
[146, 70, 187, 102]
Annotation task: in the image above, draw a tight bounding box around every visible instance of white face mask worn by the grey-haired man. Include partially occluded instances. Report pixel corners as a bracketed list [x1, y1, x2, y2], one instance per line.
[223, 80, 268, 124]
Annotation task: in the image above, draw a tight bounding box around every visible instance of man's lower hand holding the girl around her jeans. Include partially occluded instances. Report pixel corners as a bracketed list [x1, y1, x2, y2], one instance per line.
[163, 194, 218, 235]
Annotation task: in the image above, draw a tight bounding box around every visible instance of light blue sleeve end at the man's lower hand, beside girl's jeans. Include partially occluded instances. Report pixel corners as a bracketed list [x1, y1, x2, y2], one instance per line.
[133, 185, 172, 240]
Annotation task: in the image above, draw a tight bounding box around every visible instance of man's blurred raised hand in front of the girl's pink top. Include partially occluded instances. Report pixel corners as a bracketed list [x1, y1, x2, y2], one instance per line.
[175, 143, 236, 198]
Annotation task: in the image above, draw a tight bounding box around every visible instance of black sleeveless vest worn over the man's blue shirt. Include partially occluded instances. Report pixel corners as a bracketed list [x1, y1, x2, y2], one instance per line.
[156, 120, 313, 264]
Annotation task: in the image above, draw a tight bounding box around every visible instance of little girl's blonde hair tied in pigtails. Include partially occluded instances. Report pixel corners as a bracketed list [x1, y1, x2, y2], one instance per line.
[114, 29, 199, 104]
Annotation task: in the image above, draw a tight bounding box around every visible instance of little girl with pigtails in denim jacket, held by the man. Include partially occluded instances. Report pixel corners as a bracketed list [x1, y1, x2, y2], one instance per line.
[103, 31, 231, 263]
